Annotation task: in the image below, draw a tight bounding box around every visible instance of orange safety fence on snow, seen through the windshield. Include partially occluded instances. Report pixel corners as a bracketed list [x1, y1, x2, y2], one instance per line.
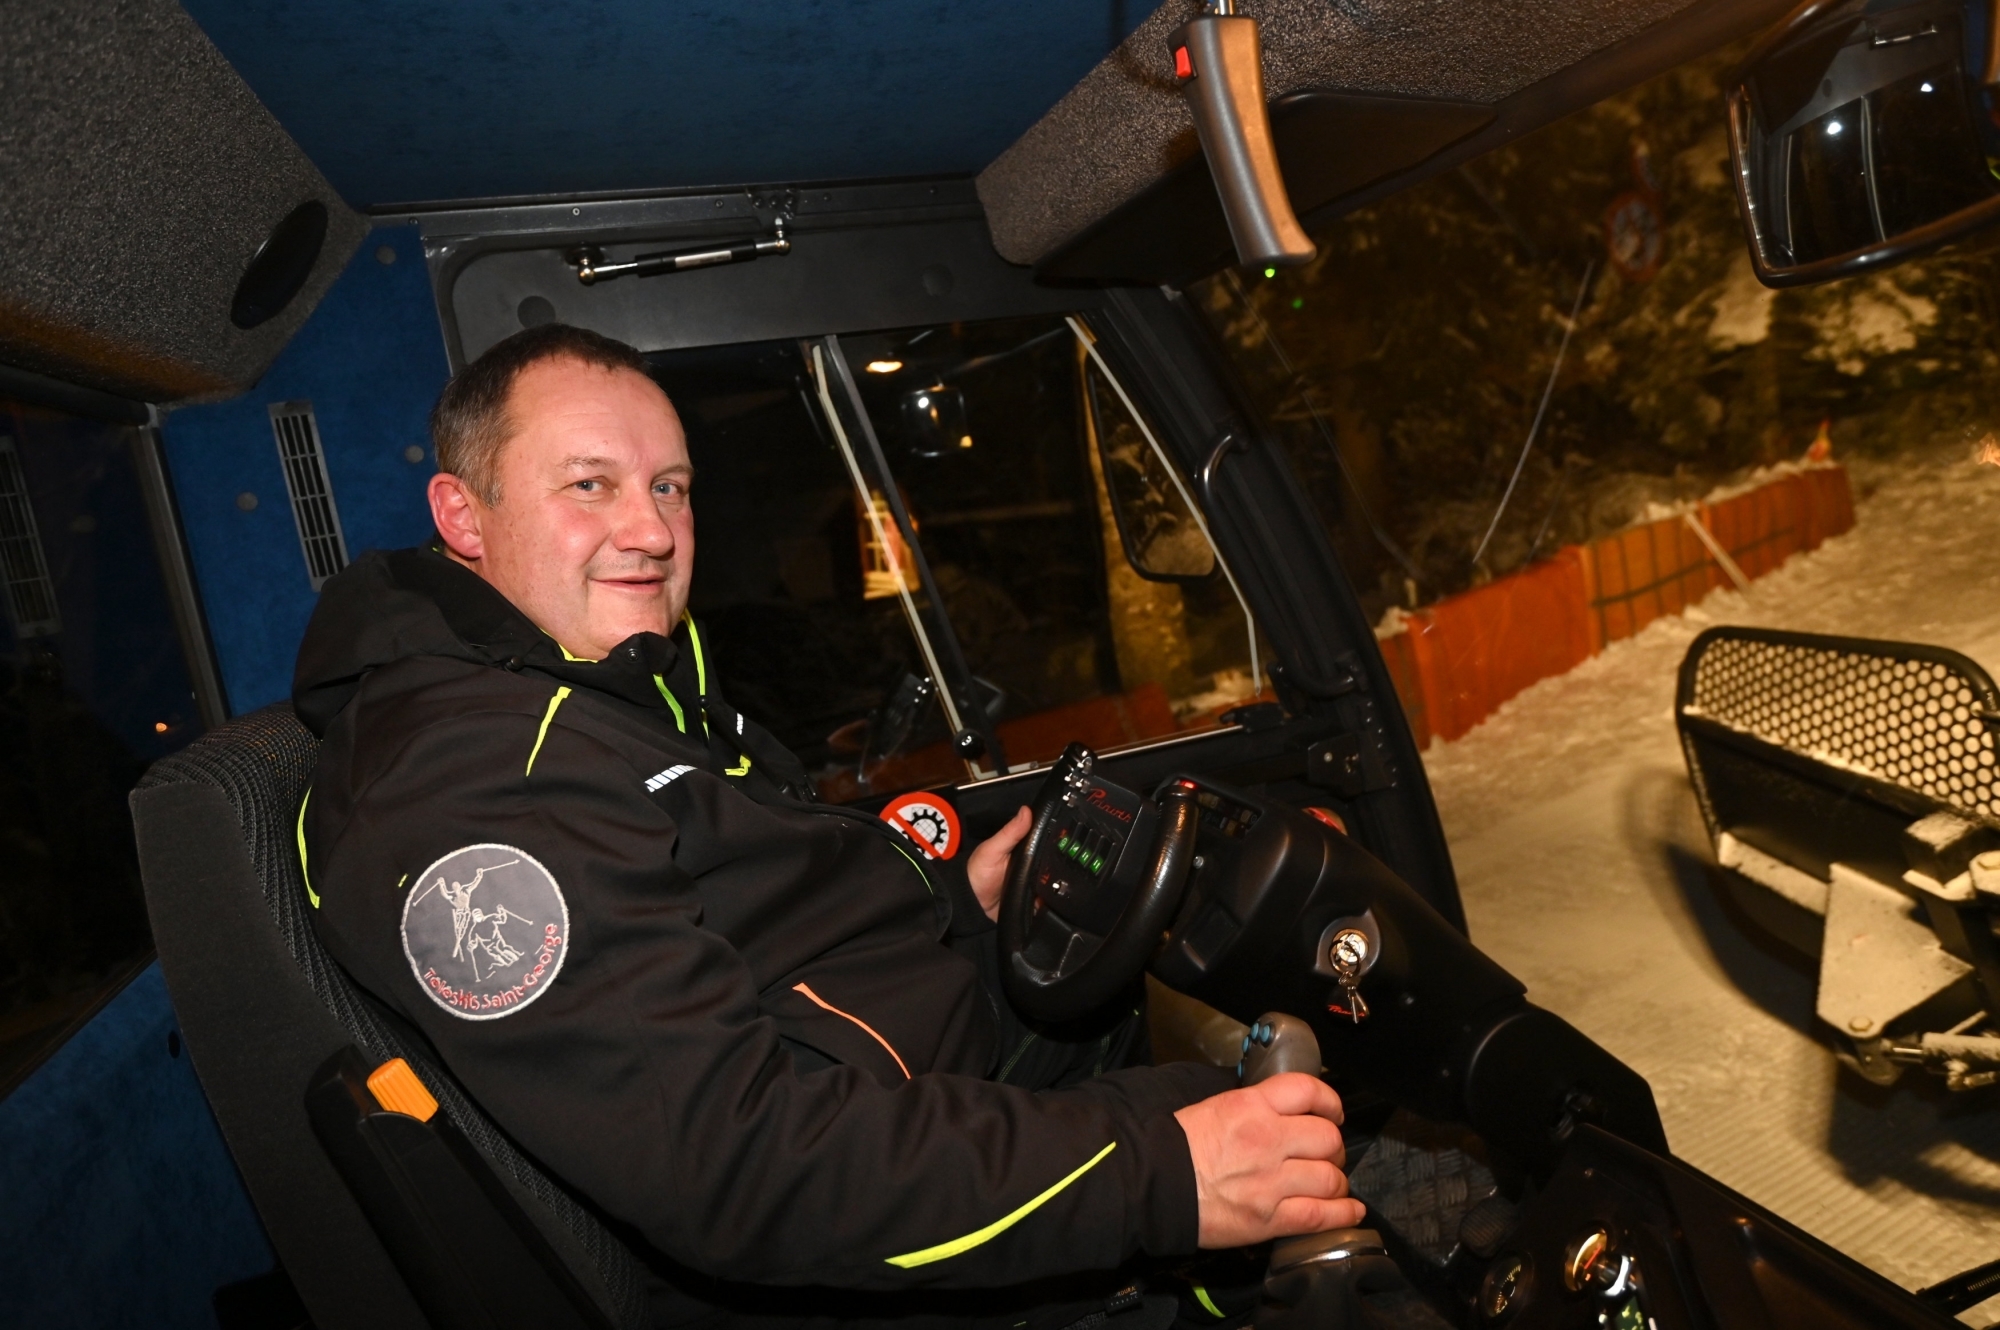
[1378, 466, 1854, 748]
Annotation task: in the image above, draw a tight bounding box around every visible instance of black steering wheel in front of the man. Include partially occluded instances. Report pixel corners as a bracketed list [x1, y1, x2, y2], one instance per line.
[1000, 744, 1200, 1020]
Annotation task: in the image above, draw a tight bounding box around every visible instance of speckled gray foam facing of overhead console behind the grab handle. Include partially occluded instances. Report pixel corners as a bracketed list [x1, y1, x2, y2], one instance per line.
[978, 0, 1720, 264]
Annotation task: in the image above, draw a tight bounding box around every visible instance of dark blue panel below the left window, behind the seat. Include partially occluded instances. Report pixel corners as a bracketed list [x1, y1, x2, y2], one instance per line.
[0, 964, 274, 1330]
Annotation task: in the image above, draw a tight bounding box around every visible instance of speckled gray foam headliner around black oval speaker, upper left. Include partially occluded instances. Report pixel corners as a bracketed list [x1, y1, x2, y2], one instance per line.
[0, 0, 368, 402]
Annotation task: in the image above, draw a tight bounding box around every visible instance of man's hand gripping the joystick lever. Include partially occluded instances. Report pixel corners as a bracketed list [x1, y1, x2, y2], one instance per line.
[1174, 1072, 1368, 1250]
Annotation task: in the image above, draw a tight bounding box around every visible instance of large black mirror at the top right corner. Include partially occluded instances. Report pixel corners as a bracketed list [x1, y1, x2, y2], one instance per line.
[1728, 0, 2000, 286]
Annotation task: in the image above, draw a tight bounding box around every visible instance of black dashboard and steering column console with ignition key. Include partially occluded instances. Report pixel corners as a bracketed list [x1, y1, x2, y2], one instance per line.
[1002, 748, 1958, 1330]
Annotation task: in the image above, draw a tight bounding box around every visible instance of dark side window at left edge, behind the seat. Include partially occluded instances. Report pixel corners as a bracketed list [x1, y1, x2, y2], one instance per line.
[0, 402, 202, 1094]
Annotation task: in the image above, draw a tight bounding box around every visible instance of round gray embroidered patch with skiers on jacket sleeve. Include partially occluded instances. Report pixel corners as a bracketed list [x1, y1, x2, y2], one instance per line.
[402, 844, 570, 1020]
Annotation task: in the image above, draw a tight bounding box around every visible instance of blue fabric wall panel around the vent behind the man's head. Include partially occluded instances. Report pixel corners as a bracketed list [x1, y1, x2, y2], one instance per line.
[164, 226, 450, 714]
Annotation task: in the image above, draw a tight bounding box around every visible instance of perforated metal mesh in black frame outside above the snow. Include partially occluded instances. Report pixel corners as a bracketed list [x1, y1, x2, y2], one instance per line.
[1680, 628, 2000, 824]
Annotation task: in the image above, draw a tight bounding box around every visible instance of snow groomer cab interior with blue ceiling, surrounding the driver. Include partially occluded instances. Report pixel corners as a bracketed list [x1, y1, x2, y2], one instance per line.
[0, 0, 1978, 1330]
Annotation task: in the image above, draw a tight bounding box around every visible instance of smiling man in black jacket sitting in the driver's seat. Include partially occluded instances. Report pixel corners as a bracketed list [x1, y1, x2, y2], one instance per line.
[294, 324, 1362, 1324]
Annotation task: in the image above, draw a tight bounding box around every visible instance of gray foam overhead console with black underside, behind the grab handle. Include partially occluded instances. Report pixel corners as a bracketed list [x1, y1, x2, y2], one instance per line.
[978, 0, 1792, 282]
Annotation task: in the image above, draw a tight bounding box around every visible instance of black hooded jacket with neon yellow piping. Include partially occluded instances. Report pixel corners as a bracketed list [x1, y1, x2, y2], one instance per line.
[294, 550, 1228, 1288]
